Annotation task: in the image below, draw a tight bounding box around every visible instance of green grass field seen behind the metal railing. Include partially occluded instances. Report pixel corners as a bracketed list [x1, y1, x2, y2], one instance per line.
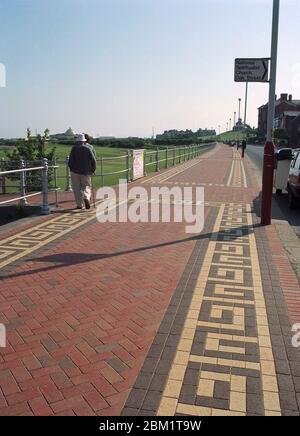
[0, 144, 216, 193]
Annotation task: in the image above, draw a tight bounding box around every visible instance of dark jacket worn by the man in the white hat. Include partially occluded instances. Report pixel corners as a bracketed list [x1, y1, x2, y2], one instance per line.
[69, 144, 96, 176]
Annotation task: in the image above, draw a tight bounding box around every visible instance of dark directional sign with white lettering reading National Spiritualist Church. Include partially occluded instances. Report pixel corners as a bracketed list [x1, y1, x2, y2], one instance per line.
[234, 58, 269, 82]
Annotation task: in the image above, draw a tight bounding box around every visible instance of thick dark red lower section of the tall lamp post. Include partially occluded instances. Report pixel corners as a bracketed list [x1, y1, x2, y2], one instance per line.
[261, 141, 275, 226]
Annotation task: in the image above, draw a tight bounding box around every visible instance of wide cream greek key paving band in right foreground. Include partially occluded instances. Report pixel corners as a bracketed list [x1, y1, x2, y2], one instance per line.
[157, 204, 281, 416]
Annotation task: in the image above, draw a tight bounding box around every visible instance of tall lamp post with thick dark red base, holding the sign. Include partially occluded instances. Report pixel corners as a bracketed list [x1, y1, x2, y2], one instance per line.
[261, 0, 280, 226]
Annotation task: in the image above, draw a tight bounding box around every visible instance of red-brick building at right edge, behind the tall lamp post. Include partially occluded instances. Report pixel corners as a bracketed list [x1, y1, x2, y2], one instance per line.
[258, 94, 300, 146]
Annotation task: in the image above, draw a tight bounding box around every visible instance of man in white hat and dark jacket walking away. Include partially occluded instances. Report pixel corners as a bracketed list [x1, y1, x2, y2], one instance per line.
[69, 134, 96, 209]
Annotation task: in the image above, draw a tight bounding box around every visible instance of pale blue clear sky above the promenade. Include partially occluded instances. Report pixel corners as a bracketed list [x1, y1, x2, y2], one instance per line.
[0, 0, 300, 137]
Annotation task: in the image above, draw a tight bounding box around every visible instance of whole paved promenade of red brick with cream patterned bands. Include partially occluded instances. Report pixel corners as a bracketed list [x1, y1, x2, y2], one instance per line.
[0, 145, 300, 416]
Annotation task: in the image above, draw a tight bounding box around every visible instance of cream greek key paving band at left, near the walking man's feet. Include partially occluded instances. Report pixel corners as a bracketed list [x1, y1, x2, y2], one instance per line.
[0, 209, 99, 269]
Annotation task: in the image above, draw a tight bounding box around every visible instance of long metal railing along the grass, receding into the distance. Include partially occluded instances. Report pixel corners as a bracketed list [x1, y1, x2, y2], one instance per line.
[0, 143, 215, 214]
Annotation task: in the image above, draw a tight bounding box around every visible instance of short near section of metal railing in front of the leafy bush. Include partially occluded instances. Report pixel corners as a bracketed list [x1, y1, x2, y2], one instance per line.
[0, 159, 60, 215]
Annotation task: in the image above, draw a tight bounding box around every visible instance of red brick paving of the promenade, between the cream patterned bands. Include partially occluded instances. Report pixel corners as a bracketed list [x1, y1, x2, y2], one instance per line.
[0, 146, 300, 415]
